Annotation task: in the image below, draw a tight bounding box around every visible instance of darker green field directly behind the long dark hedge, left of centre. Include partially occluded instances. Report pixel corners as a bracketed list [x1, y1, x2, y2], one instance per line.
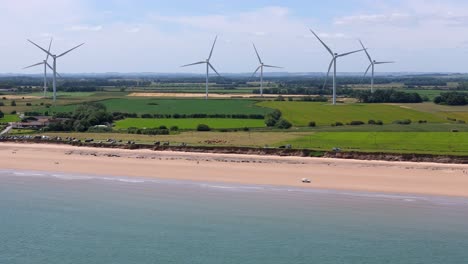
[42, 98, 273, 114]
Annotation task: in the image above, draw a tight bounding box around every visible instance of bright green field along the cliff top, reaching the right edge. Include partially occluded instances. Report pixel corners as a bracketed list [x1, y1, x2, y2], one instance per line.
[281, 132, 468, 155]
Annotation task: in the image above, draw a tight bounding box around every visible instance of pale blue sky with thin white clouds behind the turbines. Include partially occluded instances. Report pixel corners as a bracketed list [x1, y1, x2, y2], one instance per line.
[0, 0, 468, 73]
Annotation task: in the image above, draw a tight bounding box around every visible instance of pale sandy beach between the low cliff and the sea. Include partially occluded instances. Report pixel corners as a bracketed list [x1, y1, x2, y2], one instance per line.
[0, 143, 468, 197]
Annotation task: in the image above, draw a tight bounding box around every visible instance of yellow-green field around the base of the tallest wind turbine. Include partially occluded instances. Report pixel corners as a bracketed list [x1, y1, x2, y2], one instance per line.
[258, 101, 448, 126]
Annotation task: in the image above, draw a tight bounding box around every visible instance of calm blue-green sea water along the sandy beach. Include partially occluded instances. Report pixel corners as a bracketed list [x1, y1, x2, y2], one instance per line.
[0, 170, 468, 264]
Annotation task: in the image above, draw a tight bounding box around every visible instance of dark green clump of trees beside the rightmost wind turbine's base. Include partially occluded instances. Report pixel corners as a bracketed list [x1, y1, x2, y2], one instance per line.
[354, 89, 423, 103]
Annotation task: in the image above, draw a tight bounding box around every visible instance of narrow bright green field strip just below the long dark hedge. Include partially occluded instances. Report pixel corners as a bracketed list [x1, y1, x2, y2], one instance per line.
[115, 118, 265, 129]
